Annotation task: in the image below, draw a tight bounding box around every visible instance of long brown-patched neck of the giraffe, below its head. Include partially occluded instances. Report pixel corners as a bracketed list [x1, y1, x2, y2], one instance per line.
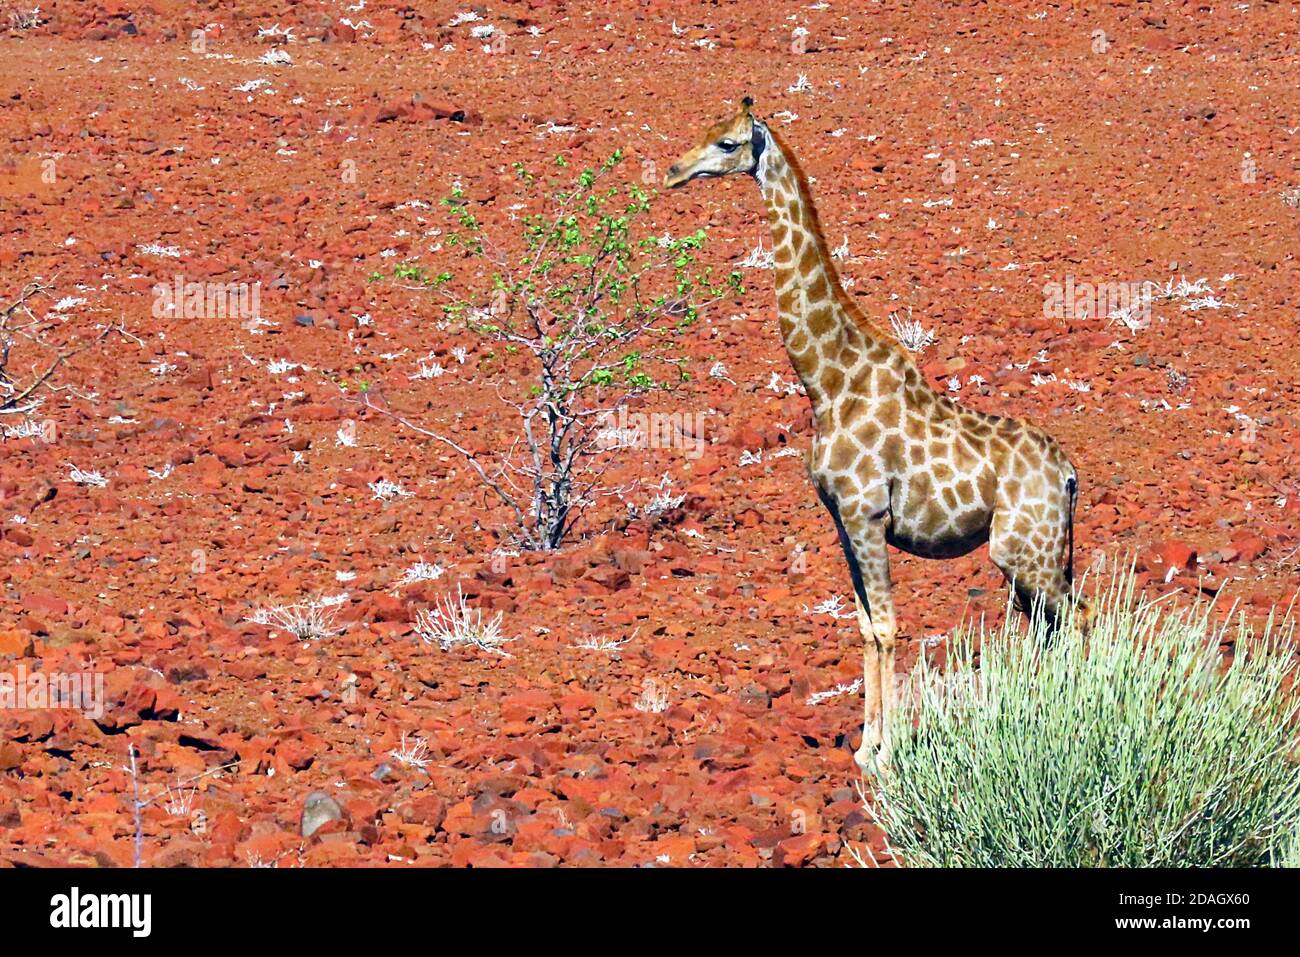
[754, 121, 889, 421]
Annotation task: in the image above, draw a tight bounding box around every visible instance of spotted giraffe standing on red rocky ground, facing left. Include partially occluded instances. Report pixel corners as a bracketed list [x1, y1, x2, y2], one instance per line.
[664, 96, 1086, 774]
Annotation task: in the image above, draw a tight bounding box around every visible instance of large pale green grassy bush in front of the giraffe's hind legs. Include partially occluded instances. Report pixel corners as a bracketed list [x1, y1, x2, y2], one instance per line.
[867, 571, 1300, 867]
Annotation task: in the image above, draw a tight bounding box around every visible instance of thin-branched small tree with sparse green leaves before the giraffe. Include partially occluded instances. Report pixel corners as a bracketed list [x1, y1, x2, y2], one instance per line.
[365, 151, 744, 551]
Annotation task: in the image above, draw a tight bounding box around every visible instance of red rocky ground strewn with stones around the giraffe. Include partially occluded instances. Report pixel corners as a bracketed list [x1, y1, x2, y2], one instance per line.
[0, 0, 1300, 866]
